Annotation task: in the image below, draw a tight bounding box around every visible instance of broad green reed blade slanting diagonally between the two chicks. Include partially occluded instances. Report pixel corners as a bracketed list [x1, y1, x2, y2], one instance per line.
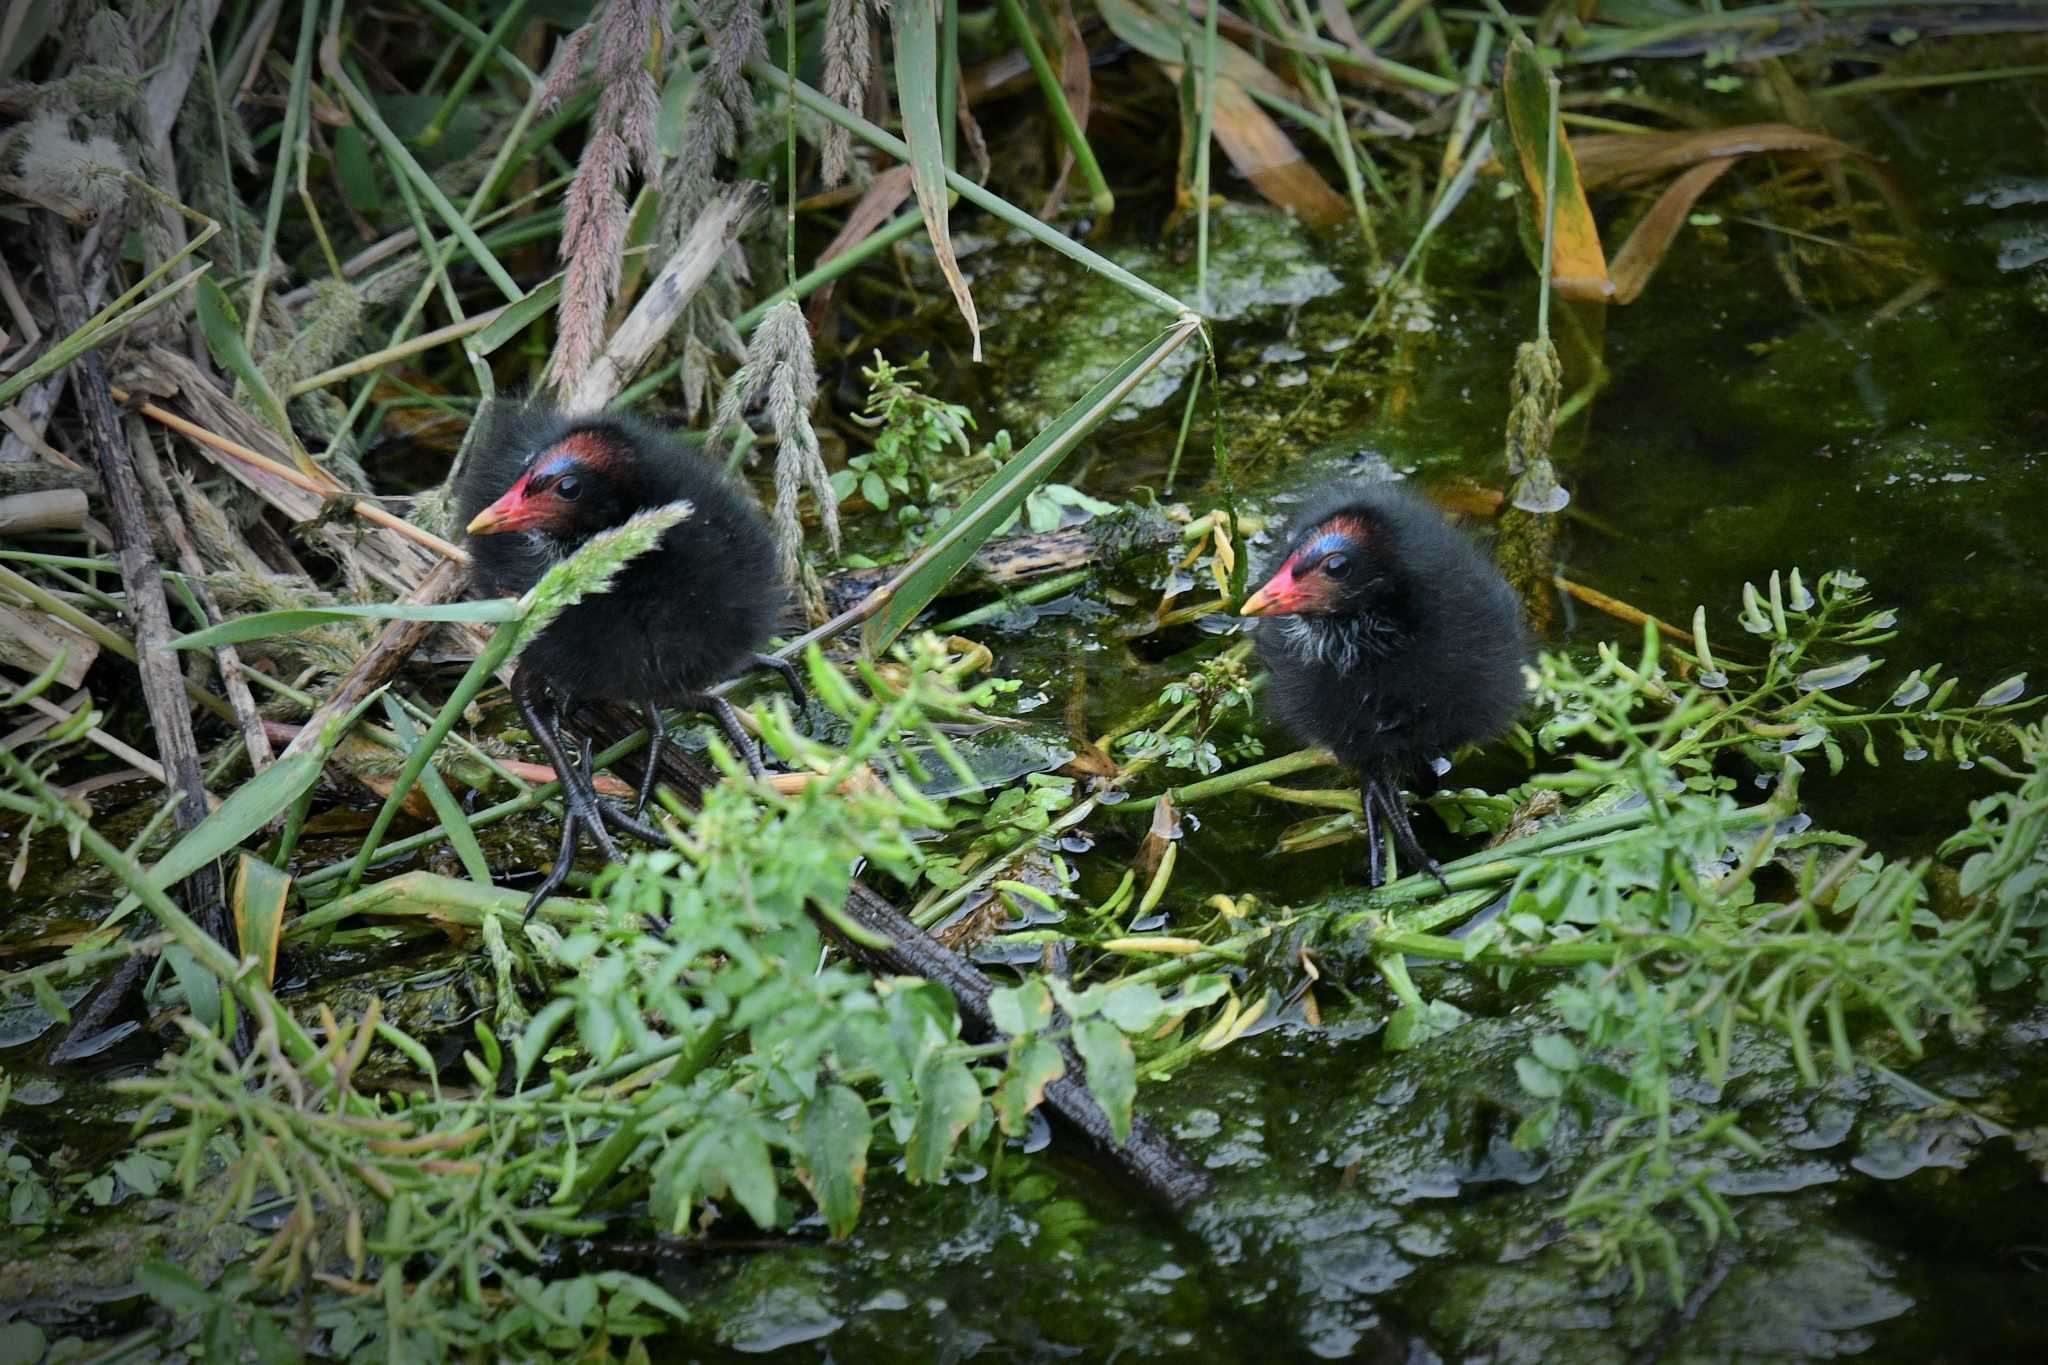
[860, 321, 1198, 657]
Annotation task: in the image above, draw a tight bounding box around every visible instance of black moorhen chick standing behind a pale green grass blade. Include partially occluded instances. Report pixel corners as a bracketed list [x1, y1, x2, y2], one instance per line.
[455, 403, 803, 915]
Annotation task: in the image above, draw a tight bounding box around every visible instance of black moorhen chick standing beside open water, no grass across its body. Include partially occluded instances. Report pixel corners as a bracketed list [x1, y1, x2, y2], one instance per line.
[1239, 483, 1528, 886]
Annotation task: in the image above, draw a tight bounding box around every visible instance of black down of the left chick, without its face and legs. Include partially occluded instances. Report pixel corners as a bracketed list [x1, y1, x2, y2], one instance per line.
[455, 403, 786, 702]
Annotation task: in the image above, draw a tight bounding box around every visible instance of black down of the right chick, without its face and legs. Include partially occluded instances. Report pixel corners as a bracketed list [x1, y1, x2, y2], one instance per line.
[1255, 483, 1528, 776]
